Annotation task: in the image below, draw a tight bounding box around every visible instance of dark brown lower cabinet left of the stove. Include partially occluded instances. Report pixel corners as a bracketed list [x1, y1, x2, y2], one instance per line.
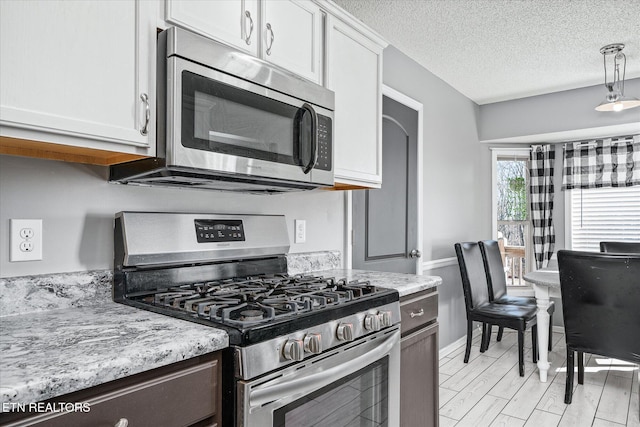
[0, 354, 221, 427]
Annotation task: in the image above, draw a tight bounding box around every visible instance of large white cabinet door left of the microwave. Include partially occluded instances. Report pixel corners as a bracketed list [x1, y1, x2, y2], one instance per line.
[0, 0, 157, 155]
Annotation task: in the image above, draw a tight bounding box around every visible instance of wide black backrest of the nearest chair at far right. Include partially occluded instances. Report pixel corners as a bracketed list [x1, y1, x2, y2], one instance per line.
[558, 250, 640, 363]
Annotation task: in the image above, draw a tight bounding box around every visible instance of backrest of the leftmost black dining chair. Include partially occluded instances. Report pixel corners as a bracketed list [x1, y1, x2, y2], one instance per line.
[455, 242, 489, 311]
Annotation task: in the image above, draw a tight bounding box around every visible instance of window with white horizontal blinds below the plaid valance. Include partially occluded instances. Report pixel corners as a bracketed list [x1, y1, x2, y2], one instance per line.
[566, 186, 640, 252]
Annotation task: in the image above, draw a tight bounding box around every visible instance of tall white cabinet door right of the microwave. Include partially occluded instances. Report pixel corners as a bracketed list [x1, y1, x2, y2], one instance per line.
[327, 16, 382, 188]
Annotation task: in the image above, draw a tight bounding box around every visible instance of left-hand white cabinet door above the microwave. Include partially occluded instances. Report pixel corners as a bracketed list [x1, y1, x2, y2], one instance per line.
[166, 0, 260, 56]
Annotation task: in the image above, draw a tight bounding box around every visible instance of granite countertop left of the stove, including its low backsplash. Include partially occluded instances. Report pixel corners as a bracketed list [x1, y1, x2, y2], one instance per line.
[0, 272, 229, 411]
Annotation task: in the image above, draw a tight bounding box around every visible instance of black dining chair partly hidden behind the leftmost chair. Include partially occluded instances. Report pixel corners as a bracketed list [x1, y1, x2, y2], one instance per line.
[478, 240, 556, 351]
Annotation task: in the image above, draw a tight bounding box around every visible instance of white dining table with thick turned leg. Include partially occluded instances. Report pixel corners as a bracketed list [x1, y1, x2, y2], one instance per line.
[524, 255, 560, 383]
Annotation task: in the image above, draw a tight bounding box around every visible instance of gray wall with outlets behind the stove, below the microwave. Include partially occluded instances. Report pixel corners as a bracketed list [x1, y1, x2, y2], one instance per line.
[0, 155, 344, 277]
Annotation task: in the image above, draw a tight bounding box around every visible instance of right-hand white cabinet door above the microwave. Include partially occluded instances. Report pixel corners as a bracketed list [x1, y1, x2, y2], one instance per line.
[261, 0, 322, 83]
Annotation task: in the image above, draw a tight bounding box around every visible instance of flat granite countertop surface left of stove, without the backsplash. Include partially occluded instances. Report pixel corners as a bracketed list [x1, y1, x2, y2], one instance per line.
[0, 302, 229, 403]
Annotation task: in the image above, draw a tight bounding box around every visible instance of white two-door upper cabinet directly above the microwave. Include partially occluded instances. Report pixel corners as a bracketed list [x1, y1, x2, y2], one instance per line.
[166, 0, 323, 83]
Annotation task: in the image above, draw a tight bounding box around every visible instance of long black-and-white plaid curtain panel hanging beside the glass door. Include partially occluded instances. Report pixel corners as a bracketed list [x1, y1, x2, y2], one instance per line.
[529, 144, 556, 269]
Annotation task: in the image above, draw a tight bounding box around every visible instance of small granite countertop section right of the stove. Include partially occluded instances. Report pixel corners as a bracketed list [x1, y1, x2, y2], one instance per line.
[312, 269, 442, 297]
